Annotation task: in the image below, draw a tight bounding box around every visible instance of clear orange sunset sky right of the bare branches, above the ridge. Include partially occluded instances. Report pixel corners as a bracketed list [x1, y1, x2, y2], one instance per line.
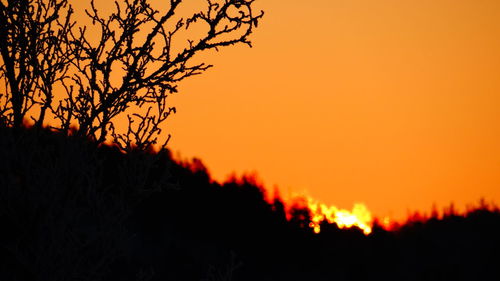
[75, 0, 500, 218]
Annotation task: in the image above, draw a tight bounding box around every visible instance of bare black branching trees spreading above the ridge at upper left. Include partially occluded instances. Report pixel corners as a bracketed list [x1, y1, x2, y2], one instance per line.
[0, 0, 263, 150]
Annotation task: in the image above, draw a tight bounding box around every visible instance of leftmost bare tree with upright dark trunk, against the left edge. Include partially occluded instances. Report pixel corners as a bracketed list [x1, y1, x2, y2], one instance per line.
[0, 0, 74, 127]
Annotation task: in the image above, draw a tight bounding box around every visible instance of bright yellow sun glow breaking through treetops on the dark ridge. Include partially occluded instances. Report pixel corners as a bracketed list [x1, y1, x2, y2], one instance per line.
[306, 197, 373, 235]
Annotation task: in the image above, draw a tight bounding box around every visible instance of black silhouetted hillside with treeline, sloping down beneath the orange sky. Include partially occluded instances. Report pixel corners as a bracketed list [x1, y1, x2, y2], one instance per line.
[0, 128, 500, 281]
